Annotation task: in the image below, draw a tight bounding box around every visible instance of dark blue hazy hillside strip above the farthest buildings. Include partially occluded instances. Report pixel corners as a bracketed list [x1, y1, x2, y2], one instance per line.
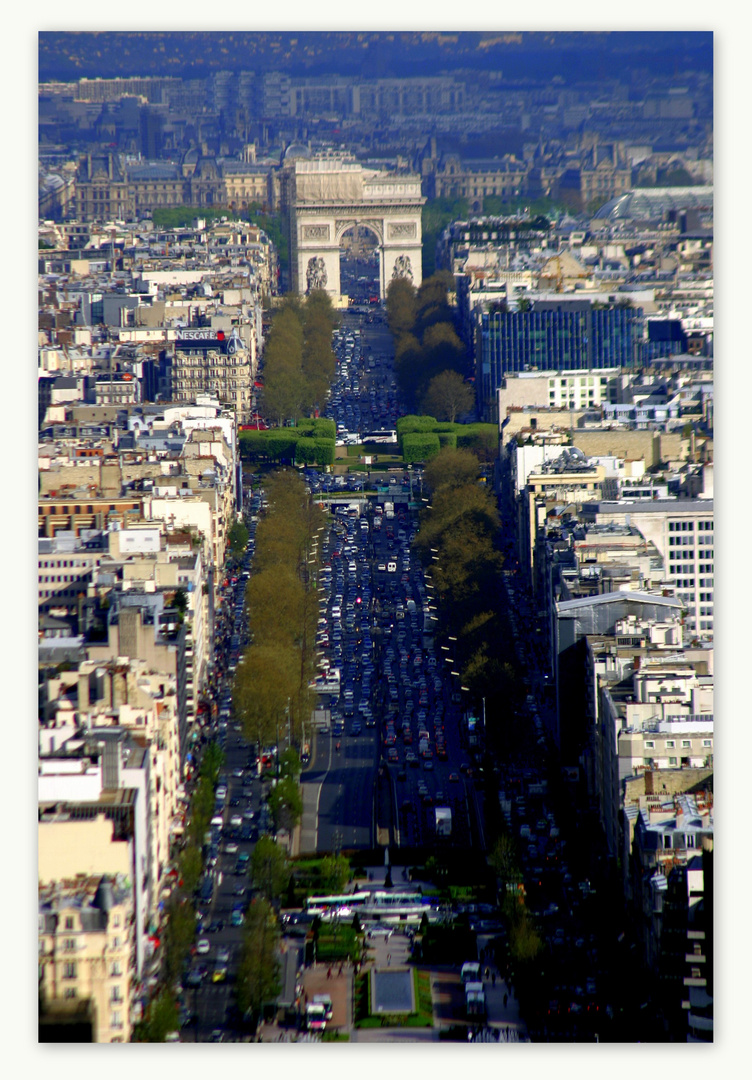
[39, 30, 713, 84]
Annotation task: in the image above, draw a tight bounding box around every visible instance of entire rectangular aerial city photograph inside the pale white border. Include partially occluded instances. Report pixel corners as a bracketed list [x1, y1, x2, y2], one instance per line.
[33, 30, 715, 1065]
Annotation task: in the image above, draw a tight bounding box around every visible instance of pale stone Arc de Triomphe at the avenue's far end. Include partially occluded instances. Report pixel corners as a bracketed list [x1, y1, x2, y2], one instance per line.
[287, 158, 426, 299]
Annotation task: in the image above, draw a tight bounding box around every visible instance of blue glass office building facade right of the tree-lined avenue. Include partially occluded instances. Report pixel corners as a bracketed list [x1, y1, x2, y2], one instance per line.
[475, 301, 644, 415]
